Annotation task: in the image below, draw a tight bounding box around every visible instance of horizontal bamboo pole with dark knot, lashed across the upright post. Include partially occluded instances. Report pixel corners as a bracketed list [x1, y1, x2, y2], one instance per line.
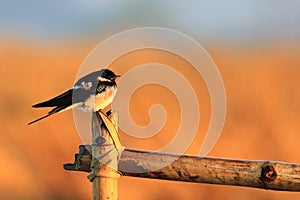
[64, 145, 300, 192]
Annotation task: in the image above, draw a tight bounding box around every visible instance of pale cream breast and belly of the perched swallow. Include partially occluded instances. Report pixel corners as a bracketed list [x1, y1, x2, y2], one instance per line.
[78, 86, 117, 112]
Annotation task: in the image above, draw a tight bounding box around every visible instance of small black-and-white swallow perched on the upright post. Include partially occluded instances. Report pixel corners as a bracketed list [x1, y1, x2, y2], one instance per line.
[28, 69, 120, 125]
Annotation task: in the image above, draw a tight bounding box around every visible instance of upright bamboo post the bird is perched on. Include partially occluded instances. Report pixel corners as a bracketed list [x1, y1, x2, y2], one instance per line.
[88, 113, 120, 200]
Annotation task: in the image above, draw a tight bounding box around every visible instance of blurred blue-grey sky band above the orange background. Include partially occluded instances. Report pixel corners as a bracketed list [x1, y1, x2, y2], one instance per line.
[0, 0, 300, 42]
